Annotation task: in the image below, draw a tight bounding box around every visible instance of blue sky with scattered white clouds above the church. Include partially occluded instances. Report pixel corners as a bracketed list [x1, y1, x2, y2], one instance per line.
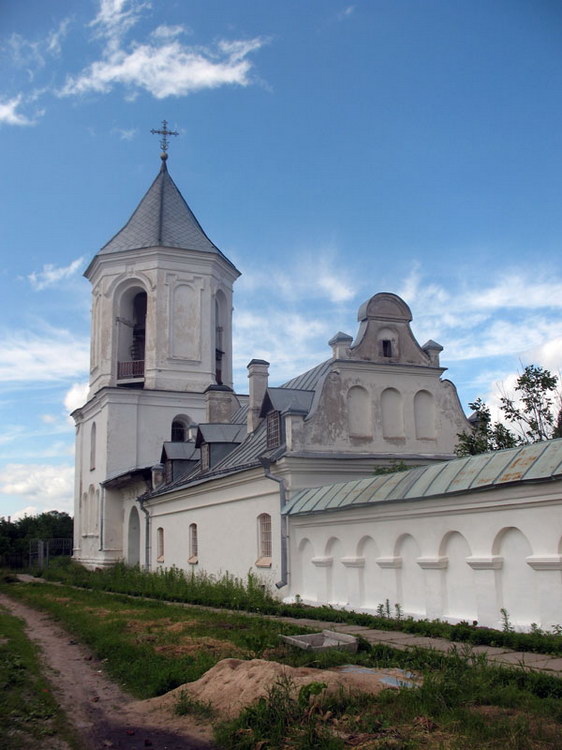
[0, 0, 562, 518]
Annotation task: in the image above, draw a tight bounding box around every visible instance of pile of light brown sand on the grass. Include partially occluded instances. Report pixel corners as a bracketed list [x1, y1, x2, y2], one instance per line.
[142, 659, 418, 718]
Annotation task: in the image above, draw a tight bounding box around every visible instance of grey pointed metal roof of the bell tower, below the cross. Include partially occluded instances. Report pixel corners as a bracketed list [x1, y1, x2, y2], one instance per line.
[98, 159, 236, 265]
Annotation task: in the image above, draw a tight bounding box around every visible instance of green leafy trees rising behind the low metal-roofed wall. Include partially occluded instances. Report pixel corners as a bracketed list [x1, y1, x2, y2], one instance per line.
[455, 365, 562, 456]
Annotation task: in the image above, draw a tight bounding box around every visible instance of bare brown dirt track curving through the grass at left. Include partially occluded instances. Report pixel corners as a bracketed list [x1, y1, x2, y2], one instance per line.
[0, 594, 213, 750]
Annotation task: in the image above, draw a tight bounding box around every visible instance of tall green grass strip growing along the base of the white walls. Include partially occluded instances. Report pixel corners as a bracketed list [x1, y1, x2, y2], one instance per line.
[37, 559, 562, 656]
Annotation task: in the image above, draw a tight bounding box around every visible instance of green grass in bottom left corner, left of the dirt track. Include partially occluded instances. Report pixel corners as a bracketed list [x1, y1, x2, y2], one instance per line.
[0, 607, 78, 750]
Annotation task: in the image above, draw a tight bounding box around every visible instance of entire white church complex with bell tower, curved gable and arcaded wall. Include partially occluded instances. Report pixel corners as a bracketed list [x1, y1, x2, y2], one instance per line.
[72, 132, 562, 629]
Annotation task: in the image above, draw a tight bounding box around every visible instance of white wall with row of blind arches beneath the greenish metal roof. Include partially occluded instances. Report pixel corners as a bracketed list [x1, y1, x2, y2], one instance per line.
[289, 482, 562, 630]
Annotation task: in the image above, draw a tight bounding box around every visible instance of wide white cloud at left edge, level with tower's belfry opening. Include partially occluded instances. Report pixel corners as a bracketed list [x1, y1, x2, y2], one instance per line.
[0, 328, 90, 384]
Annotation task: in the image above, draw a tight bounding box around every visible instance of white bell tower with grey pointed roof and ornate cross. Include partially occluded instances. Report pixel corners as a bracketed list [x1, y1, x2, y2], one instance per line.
[73, 121, 240, 565]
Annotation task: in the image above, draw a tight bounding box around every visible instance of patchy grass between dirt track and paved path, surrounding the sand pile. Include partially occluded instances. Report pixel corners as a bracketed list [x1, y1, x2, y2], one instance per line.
[4, 583, 562, 750]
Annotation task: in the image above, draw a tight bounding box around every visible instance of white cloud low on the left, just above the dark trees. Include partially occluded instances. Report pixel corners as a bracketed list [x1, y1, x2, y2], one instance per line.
[0, 463, 74, 519]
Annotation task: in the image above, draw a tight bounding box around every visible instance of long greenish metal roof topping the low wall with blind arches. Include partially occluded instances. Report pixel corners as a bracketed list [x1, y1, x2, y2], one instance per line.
[285, 438, 562, 515]
